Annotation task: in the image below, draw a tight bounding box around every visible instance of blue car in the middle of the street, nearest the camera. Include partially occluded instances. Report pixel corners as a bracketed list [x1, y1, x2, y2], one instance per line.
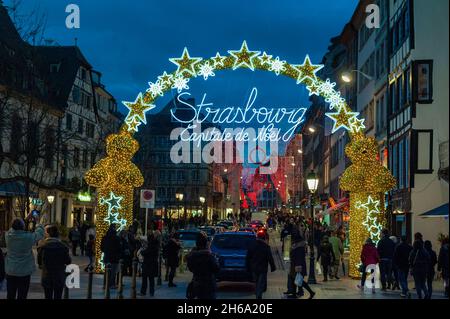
[211, 231, 256, 282]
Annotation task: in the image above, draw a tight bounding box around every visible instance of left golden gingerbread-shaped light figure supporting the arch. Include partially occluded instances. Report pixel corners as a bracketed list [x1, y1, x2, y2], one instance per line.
[84, 129, 144, 272]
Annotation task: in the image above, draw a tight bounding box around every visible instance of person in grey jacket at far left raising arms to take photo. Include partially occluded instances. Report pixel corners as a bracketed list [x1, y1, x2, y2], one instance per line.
[5, 219, 44, 300]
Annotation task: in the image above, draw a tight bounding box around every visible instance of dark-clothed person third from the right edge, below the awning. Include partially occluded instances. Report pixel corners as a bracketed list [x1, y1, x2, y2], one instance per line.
[409, 240, 430, 299]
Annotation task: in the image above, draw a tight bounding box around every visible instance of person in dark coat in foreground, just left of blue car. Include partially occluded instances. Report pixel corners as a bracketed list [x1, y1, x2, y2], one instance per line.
[186, 232, 219, 299]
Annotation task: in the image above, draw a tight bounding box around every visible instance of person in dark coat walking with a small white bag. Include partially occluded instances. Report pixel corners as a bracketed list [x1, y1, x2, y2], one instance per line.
[287, 234, 316, 299]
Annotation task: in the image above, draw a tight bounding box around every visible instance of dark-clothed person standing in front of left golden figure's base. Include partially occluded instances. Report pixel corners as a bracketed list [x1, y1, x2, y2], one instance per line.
[100, 224, 122, 289]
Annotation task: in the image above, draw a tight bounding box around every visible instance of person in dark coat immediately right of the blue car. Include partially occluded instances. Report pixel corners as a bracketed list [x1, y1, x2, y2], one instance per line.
[246, 232, 276, 299]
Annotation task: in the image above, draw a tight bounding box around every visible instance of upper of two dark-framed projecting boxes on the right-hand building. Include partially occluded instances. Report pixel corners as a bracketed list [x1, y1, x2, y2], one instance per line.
[413, 60, 433, 103]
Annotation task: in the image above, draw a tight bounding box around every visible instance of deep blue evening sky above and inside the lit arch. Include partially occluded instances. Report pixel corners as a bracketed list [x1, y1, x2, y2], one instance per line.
[5, 0, 357, 157]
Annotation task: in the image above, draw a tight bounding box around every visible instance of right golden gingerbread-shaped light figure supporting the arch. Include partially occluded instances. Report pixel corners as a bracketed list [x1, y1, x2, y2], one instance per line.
[340, 133, 396, 278]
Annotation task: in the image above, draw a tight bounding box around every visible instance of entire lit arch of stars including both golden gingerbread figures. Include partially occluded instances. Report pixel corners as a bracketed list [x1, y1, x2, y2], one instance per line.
[85, 41, 395, 277]
